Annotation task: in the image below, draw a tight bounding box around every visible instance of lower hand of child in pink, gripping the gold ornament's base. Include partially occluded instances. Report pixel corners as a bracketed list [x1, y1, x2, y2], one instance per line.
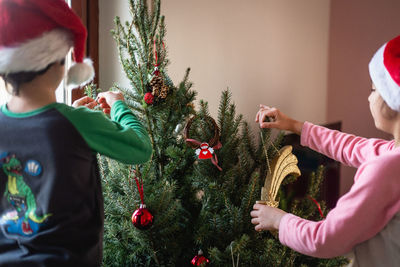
[250, 204, 286, 231]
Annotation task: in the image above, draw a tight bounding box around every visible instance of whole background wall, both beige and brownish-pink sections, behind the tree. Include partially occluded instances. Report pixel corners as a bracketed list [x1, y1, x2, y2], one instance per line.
[100, 0, 400, 198]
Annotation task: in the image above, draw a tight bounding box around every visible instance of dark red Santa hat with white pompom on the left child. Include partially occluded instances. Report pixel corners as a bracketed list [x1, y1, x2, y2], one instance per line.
[0, 0, 94, 86]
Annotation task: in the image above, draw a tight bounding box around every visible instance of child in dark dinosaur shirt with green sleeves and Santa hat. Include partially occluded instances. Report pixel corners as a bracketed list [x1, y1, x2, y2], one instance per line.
[0, 0, 152, 266]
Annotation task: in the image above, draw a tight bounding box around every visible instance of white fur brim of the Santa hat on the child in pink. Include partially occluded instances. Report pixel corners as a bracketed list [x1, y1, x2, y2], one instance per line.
[369, 44, 400, 111]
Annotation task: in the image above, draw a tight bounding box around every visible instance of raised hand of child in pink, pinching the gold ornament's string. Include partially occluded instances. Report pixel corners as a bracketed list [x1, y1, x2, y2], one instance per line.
[255, 104, 303, 134]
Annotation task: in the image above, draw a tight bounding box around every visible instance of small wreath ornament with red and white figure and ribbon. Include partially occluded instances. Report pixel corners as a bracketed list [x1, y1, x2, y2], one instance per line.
[184, 116, 222, 171]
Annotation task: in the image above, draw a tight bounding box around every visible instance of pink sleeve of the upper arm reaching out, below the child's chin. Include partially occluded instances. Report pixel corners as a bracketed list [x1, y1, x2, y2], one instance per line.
[301, 122, 394, 168]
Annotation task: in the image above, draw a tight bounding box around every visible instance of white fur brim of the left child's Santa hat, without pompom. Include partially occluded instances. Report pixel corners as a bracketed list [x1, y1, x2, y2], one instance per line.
[0, 29, 73, 74]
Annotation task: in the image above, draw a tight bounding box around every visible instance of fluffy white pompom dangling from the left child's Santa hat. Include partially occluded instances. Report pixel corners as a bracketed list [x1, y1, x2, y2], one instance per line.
[67, 58, 94, 88]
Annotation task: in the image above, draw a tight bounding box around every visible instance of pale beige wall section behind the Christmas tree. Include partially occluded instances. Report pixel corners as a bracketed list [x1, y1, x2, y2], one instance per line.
[100, 0, 330, 133]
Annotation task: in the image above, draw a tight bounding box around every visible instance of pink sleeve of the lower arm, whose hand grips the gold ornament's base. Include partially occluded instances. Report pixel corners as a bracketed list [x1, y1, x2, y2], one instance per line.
[279, 155, 400, 258]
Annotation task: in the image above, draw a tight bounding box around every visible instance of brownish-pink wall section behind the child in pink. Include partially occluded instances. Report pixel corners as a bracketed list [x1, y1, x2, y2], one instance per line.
[327, 0, 400, 197]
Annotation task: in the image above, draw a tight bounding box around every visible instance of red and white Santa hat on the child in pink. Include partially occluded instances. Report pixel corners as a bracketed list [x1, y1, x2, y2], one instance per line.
[369, 36, 400, 112]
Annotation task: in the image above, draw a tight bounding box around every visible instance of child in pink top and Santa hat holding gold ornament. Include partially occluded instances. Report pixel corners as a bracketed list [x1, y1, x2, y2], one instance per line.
[251, 36, 400, 266]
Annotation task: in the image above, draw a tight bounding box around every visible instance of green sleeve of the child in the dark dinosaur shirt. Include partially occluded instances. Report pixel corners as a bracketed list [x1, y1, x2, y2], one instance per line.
[57, 101, 152, 164]
